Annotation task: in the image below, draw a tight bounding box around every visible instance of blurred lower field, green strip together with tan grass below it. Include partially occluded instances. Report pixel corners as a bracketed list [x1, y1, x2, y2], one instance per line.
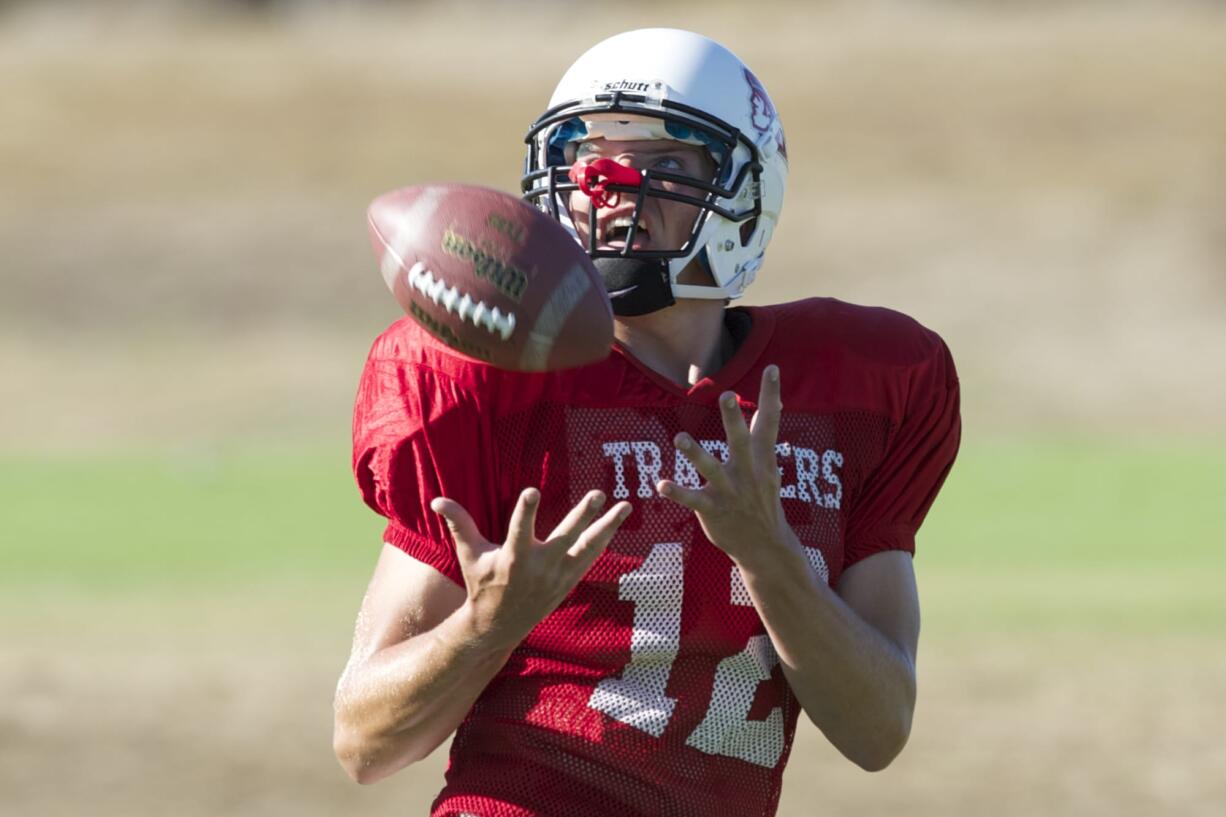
[0, 440, 1226, 817]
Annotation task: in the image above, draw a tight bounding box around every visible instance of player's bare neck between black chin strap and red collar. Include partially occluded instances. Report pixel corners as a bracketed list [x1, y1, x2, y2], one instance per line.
[613, 299, 733, 385]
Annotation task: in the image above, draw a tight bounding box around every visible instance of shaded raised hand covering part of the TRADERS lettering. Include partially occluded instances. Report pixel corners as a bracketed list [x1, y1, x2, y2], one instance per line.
[656, 366, 798, 566]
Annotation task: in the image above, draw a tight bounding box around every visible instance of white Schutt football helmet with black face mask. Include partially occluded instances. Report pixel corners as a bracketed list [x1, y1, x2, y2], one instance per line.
[522, 28, 787, 306]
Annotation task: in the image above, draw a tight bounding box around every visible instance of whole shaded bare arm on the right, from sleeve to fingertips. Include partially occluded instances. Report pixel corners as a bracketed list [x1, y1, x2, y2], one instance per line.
[658, 366, 920, 770]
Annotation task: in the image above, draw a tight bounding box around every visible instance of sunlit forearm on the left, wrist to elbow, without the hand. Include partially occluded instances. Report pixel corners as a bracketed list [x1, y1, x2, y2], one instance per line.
[333, 607, 510, 783]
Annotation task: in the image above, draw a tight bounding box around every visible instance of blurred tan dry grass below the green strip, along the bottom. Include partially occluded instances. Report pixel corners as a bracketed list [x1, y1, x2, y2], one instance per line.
[0, 588, 1226, 817]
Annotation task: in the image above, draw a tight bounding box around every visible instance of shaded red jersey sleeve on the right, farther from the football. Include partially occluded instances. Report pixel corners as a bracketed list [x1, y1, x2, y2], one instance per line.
[843, 330, 961, 569]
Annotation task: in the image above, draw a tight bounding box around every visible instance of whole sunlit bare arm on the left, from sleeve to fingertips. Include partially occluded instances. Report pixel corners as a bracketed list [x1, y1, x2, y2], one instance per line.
[333, 488, 630, 783]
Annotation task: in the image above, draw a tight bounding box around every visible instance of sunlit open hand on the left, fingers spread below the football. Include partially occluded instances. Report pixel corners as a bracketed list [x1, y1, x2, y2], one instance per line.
[430, 488, 630, 650]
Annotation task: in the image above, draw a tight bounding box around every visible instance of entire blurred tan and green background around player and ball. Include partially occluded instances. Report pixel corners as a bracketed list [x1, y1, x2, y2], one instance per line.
[0, 0, 1226, 817]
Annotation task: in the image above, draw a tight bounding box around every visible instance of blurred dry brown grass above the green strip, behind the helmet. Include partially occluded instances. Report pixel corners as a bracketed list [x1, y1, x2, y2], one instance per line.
[0, 4, 1226, 444]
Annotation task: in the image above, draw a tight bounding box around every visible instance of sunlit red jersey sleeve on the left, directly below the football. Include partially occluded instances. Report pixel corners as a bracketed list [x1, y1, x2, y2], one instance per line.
[353, 339, 501, 586]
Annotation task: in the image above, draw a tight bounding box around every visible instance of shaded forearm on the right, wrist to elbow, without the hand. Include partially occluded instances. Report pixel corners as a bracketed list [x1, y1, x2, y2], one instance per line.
[741, 545, 916, 770]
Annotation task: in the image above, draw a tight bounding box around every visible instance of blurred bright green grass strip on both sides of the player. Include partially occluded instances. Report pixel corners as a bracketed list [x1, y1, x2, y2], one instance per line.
[9, 438, 1226, 613]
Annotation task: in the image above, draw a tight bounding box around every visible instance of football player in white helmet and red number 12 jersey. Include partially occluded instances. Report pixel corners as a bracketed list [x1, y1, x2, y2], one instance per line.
[335, 29, 960, 817]
